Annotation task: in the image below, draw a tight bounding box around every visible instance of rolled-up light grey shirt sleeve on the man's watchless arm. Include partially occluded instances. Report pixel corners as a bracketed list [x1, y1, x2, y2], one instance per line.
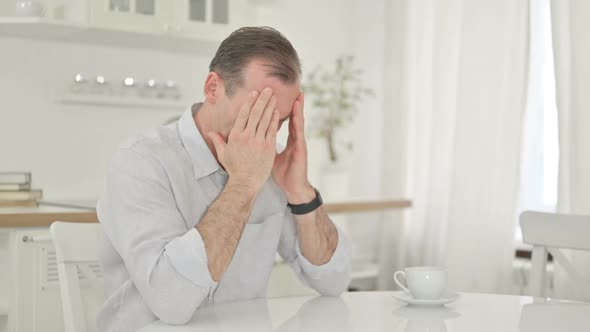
[98, 148, 216, 324]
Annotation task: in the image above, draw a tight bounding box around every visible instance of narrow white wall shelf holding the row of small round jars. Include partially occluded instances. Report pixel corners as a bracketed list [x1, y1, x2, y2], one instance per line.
[55, 94, 188, 111]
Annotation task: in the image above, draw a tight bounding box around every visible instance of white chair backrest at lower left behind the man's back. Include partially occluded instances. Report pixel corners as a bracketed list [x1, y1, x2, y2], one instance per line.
[49, 221, 102, 332]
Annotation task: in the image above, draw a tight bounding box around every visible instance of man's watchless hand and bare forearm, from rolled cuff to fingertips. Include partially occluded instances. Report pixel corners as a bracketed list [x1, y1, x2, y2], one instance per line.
[196, 88, 279, 281]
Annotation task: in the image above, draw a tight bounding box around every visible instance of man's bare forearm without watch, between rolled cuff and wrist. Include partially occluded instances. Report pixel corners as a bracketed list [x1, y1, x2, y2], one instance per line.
[196, 179, 256, 282]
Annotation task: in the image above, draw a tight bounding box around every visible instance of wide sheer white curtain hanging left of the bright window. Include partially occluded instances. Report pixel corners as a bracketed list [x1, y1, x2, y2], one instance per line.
[402, 0, 528, 292]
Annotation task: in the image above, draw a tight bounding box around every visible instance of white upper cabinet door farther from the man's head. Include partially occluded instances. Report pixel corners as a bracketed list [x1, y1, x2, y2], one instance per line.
[89, 0, 173, 33]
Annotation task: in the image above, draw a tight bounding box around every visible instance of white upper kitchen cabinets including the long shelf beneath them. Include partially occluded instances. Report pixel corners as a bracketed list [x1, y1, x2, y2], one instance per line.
[0, 0, 257, 57]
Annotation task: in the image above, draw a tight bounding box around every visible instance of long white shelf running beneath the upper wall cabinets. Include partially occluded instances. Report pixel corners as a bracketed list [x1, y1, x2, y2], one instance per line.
[0, 17, 219, 56]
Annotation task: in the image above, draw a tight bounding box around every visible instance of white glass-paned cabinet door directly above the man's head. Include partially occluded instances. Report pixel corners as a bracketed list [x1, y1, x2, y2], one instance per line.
[173, 0, 254, 42]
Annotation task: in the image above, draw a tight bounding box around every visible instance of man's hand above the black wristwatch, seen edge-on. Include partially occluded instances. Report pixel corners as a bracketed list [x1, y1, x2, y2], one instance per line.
[272, 93, 315, 204]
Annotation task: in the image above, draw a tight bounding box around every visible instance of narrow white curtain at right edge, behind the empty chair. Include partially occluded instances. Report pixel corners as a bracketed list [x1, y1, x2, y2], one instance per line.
[551, 0, 590, 298]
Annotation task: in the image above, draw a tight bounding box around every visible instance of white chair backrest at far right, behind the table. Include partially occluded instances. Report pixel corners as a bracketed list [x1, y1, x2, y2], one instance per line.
[520, 211, 590, 300]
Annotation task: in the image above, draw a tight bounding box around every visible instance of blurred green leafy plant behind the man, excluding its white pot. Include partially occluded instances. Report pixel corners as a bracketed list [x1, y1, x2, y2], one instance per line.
[302, 55, 373, 163]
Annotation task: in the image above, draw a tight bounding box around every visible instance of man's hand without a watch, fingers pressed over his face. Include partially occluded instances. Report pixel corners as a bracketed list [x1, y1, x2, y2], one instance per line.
[208, 88, 279, 193]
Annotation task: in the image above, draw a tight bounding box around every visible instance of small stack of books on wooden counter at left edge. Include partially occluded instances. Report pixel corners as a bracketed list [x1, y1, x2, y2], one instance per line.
[0, 172, 43, 208]
